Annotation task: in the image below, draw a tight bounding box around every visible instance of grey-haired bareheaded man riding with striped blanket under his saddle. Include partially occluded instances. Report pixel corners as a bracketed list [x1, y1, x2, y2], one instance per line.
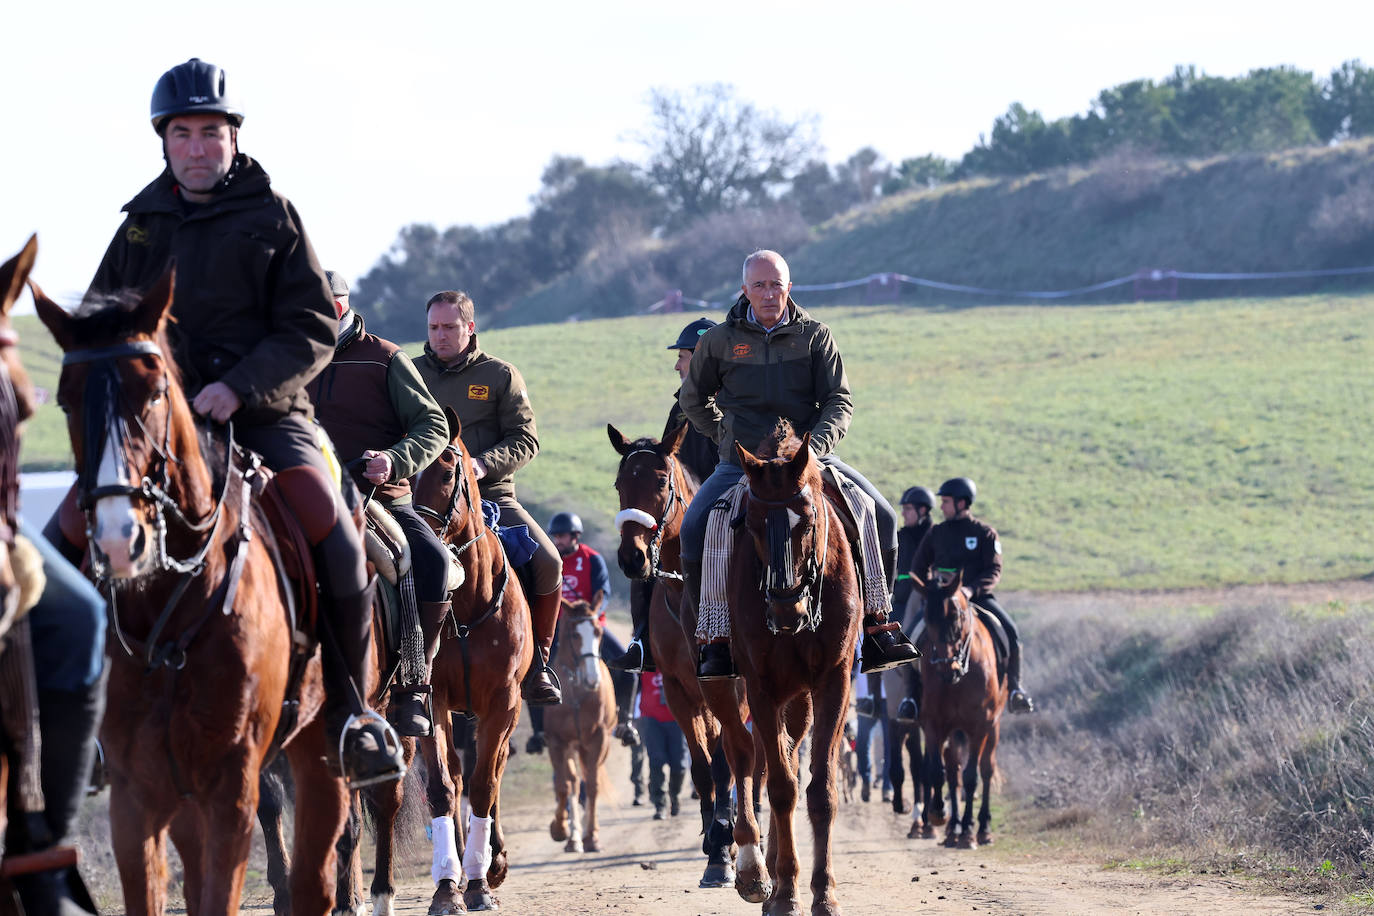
[679, 251, 919, 678]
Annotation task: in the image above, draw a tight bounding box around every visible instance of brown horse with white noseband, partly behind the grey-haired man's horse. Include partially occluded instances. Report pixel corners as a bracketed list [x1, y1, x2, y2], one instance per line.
[606, 424, 760, 902]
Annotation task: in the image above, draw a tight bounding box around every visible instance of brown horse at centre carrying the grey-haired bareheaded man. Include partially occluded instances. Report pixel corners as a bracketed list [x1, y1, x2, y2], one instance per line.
[727, 423, 861, 916]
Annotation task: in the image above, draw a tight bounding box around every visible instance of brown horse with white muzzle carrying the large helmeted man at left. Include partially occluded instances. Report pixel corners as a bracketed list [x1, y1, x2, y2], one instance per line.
[33, 271, 346, 916]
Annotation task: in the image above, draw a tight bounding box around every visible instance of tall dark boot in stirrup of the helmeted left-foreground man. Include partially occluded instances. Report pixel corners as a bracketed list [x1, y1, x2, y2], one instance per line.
[322, 577, 405, 788]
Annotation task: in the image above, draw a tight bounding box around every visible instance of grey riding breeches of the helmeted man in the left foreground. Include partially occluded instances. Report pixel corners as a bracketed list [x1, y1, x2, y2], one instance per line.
[234, 413, 367, 597]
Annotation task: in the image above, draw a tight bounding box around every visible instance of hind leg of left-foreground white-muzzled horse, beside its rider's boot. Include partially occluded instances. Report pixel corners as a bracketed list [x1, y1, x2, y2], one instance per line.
[286, 717, 350, 916]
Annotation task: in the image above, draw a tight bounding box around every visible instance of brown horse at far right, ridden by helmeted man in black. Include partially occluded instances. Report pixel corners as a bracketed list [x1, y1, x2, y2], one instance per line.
[912, 574, 1007, 849]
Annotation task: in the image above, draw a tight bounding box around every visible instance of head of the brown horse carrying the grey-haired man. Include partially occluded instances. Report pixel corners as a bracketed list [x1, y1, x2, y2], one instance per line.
[735, 427, 830, 633]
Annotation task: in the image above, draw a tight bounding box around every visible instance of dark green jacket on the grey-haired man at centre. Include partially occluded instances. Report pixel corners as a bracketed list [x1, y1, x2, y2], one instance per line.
[677, 297, 853, 464]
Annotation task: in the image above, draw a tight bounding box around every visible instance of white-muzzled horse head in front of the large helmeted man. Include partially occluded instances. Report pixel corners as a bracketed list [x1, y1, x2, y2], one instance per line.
[30, 268, 218, 581]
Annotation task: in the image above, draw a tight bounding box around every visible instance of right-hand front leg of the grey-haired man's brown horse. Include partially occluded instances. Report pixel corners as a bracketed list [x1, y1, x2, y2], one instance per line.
[807, 665, 840, 916]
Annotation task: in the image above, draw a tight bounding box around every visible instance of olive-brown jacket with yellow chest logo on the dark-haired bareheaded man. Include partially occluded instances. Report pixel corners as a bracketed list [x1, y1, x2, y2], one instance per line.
[415, 340, 539, 500]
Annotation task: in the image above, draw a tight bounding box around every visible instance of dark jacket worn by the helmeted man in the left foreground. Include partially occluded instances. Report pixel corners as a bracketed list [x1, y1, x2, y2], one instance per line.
[91, 154, 338, 426]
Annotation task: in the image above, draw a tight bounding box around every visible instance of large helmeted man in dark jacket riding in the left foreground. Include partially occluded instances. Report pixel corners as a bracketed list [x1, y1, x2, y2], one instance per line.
[69, 58, 405, 783]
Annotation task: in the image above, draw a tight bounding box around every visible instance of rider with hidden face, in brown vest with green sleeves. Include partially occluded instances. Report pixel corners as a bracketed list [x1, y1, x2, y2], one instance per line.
[306, 271, 449, 737]
